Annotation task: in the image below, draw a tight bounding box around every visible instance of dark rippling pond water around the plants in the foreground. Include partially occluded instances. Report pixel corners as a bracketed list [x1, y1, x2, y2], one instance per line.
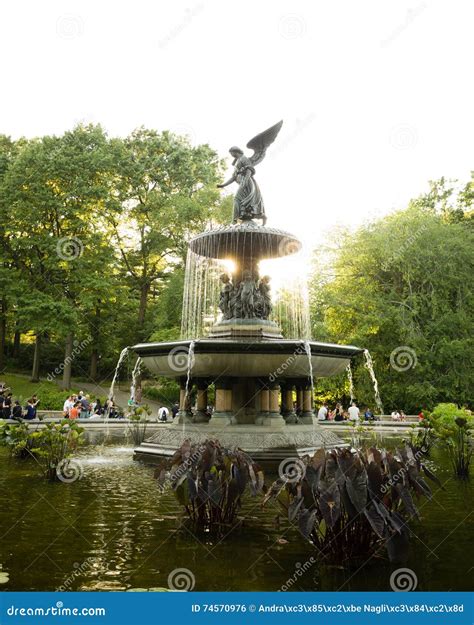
[0, 438, 474, 591]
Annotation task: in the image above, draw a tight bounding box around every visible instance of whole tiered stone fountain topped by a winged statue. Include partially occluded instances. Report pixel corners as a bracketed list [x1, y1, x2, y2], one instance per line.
[132, 122, 362, 461]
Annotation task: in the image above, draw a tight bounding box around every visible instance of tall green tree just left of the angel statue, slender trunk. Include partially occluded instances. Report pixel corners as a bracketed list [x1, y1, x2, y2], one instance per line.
[103, 128, 227, 339]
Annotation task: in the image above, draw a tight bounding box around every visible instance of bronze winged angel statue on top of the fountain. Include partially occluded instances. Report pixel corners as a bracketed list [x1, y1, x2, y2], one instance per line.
[217, 121, 283, 225]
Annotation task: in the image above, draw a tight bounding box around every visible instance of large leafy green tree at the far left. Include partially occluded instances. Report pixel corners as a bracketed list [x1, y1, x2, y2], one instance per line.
[0, 126, 115, 388]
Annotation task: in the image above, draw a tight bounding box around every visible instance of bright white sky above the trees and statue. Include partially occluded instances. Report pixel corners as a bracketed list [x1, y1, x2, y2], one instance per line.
[0, 0, 474, 256]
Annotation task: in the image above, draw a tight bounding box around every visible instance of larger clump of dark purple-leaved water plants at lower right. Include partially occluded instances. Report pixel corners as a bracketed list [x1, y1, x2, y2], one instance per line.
[263, 444, 440, 563]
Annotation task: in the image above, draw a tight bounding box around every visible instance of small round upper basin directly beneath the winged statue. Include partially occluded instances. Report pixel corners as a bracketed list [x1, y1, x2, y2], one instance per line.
[189, 221, 301, 259]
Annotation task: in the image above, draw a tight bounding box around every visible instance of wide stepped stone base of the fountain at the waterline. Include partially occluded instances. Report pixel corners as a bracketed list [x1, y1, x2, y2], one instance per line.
[135, 421, 343, 463]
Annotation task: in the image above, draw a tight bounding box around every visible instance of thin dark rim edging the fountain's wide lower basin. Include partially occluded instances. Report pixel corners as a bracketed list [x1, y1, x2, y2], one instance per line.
[131, 339, 364, 359]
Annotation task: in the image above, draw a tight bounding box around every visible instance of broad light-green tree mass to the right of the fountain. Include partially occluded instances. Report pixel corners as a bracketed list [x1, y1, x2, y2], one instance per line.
[311, 180, 474, 412]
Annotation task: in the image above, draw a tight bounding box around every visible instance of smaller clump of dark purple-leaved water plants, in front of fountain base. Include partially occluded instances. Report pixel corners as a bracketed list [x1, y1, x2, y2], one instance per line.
[155, 439, 264, 531]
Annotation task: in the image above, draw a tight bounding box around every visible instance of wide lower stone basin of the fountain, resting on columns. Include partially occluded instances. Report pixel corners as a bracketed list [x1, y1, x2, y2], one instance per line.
[132, 339, 363, 380]
